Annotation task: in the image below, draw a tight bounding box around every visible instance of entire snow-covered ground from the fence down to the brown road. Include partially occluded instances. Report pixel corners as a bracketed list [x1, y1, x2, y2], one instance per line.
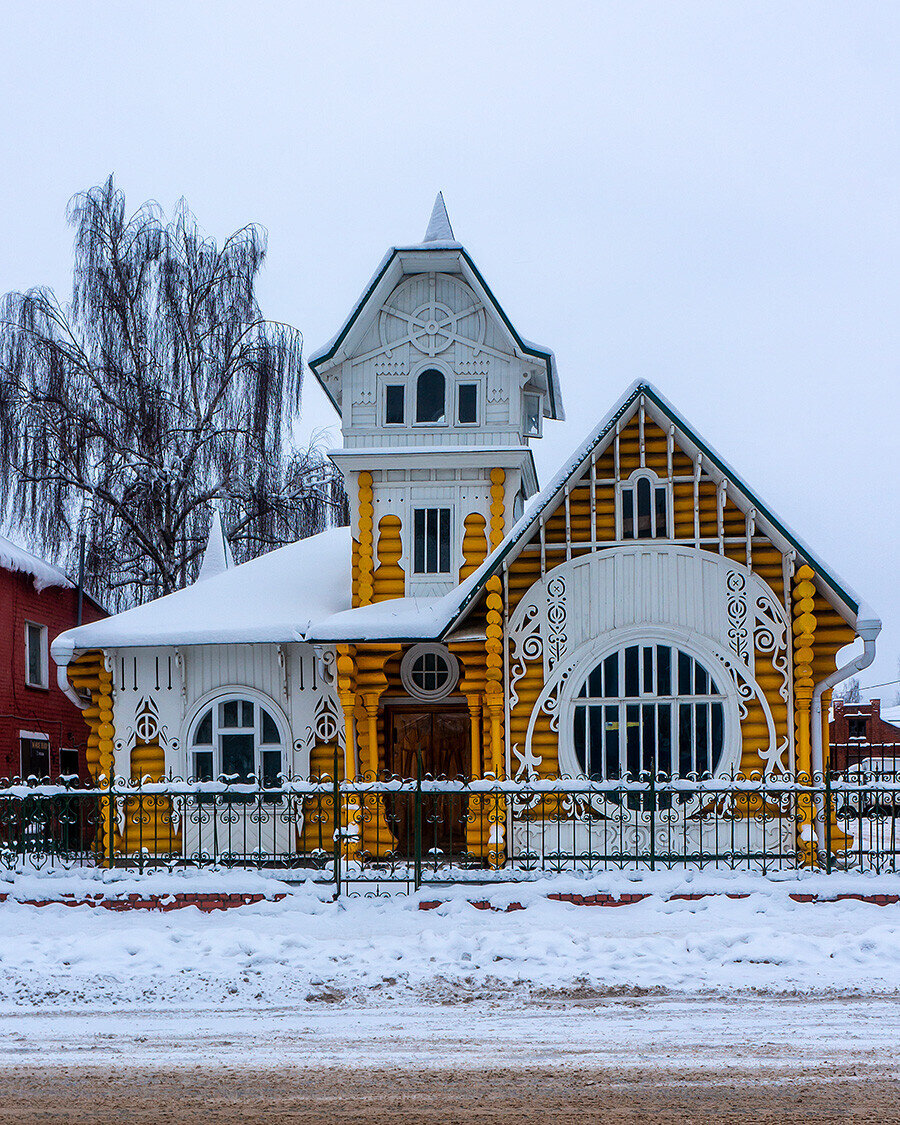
[0, 868, 900, 1079]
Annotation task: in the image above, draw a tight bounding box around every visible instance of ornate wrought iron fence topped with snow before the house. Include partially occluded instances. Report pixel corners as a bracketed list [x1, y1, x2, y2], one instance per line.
[0, 765, 900, 893]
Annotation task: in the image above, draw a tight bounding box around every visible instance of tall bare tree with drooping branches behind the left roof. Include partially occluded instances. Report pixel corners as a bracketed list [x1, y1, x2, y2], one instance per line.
[0, 177, 345, 606]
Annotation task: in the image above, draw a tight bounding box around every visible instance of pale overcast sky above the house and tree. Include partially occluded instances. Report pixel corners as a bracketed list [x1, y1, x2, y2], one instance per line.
[0, 0, 900, 701]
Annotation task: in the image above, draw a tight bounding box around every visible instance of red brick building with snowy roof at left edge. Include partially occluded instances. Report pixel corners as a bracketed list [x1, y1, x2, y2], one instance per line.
[0, 537, 106, 781]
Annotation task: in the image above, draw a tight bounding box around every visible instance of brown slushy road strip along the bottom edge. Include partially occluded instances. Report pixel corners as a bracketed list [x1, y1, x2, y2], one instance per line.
[0, 1067, 900, 1125]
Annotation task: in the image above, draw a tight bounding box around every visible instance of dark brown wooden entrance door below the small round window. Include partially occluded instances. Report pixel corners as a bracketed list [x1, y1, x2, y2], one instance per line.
[385, 708, 470, 858]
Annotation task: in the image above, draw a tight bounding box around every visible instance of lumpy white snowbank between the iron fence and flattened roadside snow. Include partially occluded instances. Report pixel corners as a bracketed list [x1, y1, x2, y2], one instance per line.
[0, 875, 900, 1013]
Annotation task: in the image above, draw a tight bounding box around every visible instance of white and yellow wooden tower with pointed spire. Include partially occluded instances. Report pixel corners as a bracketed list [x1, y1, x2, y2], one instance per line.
[309, 192, 563, 605]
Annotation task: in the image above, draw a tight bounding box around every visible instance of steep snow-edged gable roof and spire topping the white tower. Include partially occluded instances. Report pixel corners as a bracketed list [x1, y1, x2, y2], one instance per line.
[307, 192, 566, 421]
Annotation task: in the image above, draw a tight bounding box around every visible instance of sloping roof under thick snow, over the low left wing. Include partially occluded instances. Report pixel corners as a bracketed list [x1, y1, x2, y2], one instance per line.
[52, 528, 350, 664]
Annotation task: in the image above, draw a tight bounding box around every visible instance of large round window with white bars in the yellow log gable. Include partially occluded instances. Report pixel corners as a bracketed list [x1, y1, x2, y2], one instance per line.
[573, 644, 726, 781]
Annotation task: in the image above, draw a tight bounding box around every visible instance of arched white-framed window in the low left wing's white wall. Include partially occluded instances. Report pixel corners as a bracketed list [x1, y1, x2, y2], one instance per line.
[190, 699, 284, 789]
